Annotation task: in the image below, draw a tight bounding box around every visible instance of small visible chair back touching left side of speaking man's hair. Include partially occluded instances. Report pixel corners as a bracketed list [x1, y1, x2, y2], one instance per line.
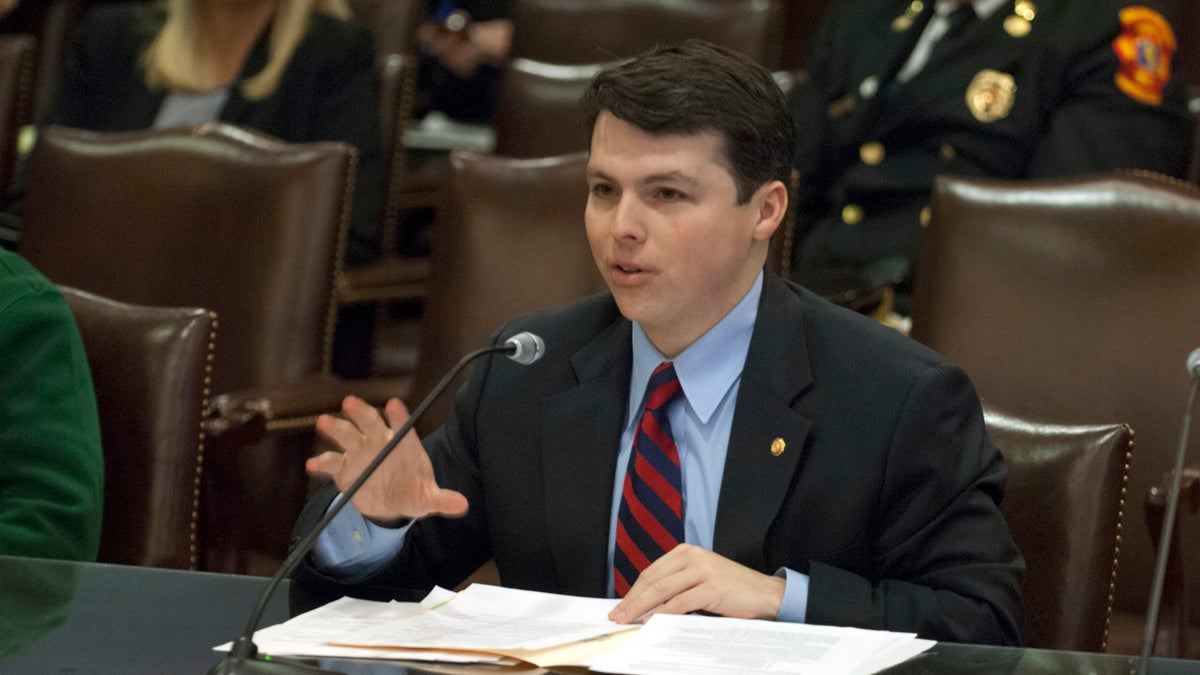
[494, 59, 604, 157]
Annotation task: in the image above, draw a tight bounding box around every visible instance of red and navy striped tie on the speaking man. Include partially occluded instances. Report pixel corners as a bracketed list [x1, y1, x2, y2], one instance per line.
[612, 362, 683, 598]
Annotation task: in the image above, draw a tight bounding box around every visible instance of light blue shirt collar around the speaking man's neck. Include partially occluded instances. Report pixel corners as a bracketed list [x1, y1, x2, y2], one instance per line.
[629, 271, 763, 424]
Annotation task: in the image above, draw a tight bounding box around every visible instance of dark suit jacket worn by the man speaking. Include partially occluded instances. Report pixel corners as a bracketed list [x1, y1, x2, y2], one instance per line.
[293, 273, 1024, 644]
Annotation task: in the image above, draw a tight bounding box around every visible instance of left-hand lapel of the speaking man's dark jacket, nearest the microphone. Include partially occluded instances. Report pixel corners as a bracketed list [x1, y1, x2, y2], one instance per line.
[541, 319, 632, 596]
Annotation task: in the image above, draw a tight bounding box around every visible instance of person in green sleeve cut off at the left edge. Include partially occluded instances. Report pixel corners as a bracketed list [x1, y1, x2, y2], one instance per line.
[0, 243, 104, 561]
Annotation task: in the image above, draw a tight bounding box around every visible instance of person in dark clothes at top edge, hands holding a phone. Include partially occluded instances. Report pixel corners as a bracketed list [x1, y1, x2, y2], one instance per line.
[415, 0, 512, 124]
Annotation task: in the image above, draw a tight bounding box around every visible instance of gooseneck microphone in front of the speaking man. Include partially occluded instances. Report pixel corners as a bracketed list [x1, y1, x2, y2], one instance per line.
[208, 331, 546, 675]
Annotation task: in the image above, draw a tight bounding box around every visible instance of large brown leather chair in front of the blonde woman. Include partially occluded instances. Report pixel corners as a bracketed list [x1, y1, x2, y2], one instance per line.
[19, 124, 376, 571]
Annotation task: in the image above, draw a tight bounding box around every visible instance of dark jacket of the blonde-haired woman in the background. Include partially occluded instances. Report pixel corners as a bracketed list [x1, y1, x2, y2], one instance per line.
[46, 2, 384, 264]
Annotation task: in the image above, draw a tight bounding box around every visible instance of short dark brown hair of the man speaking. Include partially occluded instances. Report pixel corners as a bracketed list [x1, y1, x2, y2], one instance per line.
[580, 40, 796, 204]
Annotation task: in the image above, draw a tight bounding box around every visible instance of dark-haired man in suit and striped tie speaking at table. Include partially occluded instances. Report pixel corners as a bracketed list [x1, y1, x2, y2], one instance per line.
[293, 41, 1024, 645]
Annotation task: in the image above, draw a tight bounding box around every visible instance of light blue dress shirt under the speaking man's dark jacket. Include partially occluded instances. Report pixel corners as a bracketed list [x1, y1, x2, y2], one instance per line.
[313, 267, 809, 622]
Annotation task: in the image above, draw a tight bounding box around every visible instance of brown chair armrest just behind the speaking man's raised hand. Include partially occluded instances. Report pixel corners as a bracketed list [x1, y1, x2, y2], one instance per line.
[205, 374, 413, 441]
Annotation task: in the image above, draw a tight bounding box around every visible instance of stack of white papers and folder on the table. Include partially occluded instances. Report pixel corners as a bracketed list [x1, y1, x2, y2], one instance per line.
[217, 584, 934, 675]
